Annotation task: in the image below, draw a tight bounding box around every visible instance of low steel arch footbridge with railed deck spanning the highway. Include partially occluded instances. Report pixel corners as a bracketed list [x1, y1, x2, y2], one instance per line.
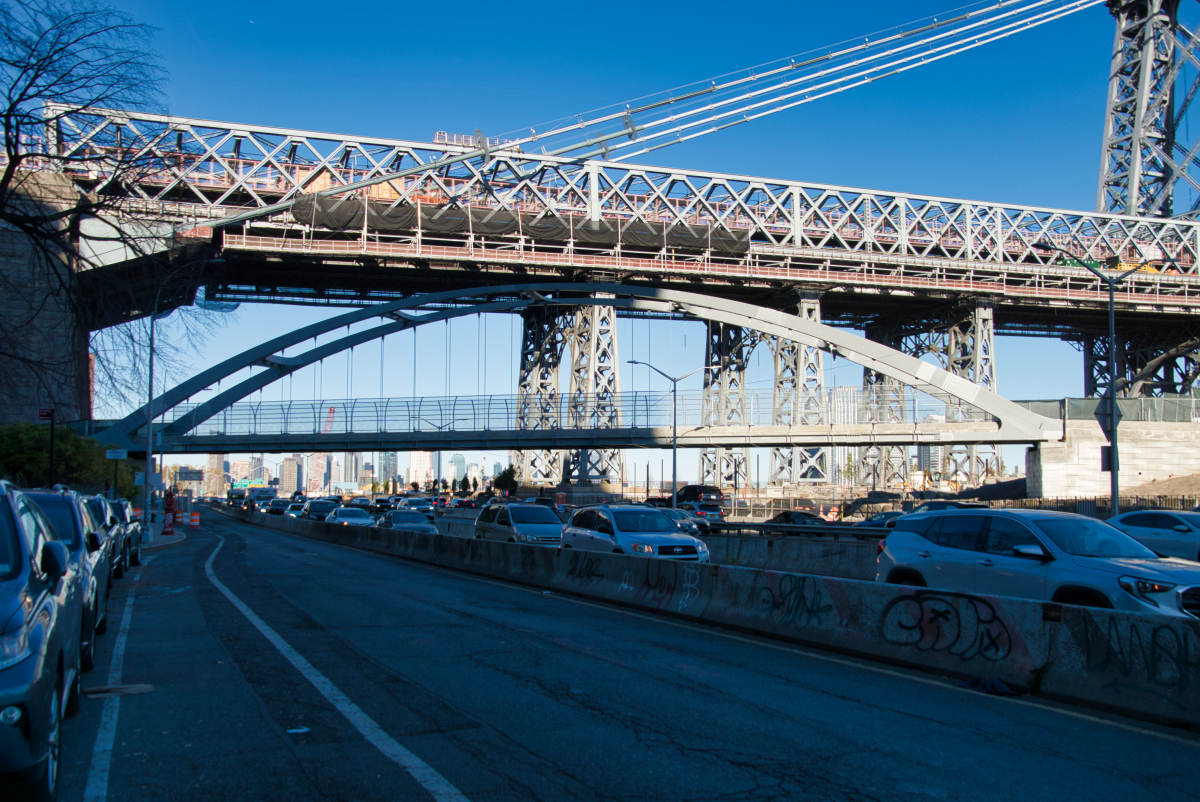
[98, 282, 1062, 480]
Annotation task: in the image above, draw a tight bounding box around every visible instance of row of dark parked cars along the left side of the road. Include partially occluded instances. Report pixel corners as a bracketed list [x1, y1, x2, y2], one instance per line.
[0, 481, 142, 800]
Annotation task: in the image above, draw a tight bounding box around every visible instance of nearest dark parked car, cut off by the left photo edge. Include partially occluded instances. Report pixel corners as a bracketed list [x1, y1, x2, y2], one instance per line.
[0, 483, 88, 800]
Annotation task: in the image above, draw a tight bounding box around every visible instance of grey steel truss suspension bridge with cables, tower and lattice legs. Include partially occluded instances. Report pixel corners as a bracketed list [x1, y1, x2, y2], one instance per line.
[28, 0, 1200, 485]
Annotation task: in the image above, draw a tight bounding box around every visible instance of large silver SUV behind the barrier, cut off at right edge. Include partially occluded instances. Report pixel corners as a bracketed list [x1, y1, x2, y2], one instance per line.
[875, 509, 1200, 618]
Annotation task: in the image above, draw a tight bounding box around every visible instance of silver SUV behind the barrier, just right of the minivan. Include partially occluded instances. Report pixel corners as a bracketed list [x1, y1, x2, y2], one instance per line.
[563, 505, 709, 563]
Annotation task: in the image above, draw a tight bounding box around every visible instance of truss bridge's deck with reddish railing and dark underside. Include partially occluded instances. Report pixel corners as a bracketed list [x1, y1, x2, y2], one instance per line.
[201, 232, 1200, 339]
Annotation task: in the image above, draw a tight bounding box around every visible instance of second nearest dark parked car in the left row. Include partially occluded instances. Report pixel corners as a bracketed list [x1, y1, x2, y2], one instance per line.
[25, 490, 113, 671]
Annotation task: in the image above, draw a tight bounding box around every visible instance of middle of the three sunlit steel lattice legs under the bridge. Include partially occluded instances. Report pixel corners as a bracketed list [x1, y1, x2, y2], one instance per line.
[767, 293, 830, 486]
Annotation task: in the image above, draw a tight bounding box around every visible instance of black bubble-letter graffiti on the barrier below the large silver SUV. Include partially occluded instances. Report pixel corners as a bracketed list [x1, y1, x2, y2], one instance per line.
[880, 591, 1013, 663]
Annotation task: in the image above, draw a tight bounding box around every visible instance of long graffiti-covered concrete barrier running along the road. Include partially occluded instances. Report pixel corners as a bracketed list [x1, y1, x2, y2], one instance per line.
[215, 507, 1200, 731]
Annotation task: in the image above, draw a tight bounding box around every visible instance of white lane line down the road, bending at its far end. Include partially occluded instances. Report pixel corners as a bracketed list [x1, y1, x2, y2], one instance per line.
[204, 534, 469, 802]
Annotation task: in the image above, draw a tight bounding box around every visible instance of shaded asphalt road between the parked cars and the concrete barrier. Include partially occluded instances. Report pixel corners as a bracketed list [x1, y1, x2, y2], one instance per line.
[62, 514, 1200, 802]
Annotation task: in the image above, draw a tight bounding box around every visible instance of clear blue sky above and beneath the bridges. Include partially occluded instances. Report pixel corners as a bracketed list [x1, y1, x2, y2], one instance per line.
[110, 0, 1114, 477]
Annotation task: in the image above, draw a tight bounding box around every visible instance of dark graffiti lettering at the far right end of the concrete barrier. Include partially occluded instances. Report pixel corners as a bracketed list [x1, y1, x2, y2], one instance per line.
[1082, 615, 1200, 693]
